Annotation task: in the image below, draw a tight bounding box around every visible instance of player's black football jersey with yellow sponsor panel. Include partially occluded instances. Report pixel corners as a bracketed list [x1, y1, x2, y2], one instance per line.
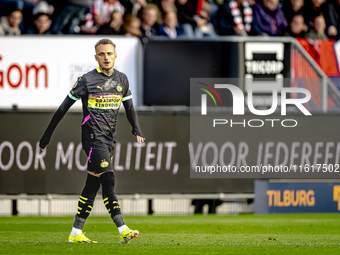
[68, 67, 132, 147]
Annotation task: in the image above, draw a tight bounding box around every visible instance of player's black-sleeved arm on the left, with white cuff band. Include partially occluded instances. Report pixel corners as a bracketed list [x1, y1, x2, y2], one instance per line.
[39, 78, 86, 151]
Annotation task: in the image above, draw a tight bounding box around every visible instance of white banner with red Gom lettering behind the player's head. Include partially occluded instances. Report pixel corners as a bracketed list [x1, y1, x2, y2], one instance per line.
[0, 36, 142, 109]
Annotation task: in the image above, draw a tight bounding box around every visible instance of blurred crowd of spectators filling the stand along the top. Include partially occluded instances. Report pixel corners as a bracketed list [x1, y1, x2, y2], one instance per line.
[0, 0, 340, 43]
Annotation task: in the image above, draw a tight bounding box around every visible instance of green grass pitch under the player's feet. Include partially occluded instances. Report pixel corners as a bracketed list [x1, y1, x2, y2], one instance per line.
[0, 214, 340, 255]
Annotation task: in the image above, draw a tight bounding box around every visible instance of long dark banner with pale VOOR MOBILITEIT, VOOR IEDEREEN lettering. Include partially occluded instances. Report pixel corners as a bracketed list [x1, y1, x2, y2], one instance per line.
[0, 111, 340, 194]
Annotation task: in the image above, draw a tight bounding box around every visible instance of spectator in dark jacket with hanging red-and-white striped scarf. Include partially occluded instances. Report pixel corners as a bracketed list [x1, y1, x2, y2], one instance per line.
[217, 0, 261, 36]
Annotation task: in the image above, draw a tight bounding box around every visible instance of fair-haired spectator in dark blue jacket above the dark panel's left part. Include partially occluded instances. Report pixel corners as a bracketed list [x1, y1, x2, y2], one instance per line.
[158, 11, 184, 39]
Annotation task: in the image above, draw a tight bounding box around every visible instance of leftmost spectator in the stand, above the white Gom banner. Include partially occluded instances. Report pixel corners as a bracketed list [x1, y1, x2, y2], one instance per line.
[0, 8, 22, 35]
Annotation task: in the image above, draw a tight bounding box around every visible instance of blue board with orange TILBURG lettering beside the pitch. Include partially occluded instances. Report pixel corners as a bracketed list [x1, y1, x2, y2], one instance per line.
[254, 180, 340, 214]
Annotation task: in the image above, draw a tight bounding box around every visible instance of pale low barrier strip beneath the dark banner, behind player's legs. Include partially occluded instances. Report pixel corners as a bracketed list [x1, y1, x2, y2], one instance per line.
[0, 193, 254, 216]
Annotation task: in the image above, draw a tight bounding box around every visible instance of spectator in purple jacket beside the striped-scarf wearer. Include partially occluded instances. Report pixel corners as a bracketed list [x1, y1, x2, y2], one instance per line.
[254, 0, 288, 36]
